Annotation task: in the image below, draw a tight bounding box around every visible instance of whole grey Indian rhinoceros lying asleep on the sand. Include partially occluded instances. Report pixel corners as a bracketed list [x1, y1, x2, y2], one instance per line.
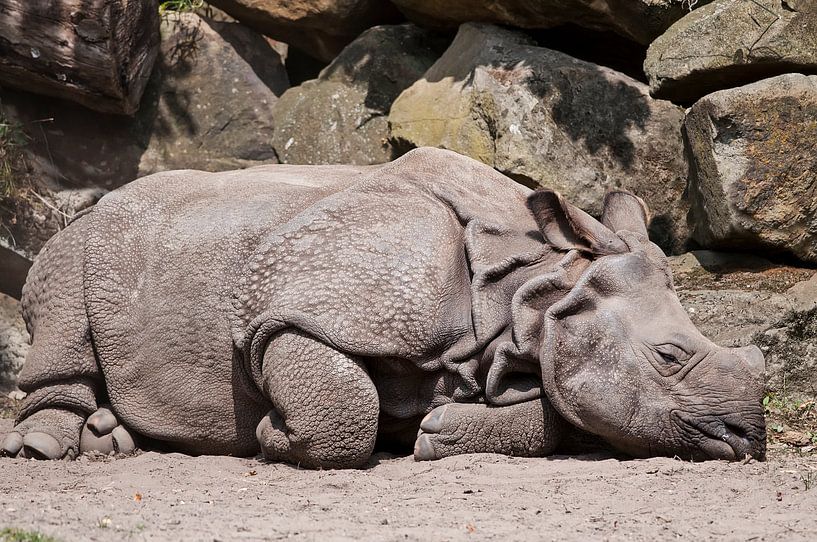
[0, 149, 765, 468]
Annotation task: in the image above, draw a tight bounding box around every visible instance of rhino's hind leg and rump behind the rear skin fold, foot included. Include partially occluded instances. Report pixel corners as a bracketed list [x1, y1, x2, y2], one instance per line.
[0, 217, 104, 459]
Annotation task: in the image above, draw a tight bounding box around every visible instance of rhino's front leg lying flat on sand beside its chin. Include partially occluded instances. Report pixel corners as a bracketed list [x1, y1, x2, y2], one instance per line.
[414, 399, 565, 461]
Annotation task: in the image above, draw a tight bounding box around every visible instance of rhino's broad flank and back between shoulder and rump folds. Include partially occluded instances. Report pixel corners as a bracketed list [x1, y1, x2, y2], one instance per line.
[84, 166, 365, 453]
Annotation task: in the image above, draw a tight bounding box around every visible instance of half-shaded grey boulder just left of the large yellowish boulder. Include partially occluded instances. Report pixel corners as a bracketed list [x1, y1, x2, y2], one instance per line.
[272, 24, 444, 165]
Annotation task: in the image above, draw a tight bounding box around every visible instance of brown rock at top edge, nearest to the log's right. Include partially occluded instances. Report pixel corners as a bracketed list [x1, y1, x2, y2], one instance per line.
[209, 0, 400, 62]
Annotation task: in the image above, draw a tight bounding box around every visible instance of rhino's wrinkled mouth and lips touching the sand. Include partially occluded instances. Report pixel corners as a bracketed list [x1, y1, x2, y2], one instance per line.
[675, 412, 765, 461]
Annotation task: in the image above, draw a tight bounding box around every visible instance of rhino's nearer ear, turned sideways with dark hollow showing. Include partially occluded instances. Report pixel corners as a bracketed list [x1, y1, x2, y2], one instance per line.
[528, 190, 629, 256]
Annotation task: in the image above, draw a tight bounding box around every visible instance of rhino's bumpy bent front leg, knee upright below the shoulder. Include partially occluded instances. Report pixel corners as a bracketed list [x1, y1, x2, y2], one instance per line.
[256, 331, 380, 468]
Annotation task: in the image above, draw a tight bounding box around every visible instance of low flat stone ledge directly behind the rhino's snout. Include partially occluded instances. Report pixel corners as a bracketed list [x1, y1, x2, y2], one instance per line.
[670, 252, 817, 399]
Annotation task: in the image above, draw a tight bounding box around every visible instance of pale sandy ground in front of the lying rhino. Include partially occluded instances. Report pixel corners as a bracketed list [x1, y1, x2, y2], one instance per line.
[0, 420, 817, 541]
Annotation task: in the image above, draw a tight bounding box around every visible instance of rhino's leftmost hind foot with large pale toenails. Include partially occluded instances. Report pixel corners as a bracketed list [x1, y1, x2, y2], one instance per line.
[0, 408, 83, 459]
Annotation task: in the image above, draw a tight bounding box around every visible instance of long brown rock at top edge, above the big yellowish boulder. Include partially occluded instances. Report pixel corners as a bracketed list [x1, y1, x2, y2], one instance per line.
[392, 0, 708, 45]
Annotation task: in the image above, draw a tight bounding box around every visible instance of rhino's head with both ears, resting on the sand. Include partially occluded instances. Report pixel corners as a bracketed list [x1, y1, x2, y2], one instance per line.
[528, 191, 766, 459]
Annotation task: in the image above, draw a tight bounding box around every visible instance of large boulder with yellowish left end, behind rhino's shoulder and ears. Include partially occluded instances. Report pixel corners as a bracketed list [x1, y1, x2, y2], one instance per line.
[389, 24, 688, 251]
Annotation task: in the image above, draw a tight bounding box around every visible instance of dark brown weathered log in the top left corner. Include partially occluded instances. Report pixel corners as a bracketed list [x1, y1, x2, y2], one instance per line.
[0, 0, 159, 114]
